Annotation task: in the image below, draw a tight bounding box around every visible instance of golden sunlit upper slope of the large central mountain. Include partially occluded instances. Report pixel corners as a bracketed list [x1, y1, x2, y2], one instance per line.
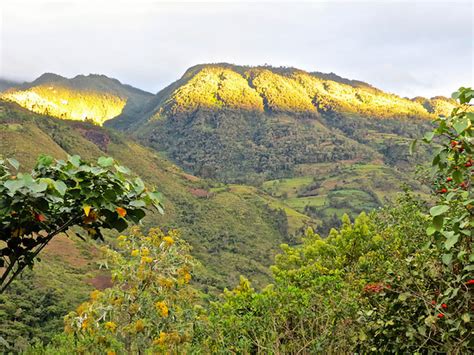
[158, 65, 455, 119]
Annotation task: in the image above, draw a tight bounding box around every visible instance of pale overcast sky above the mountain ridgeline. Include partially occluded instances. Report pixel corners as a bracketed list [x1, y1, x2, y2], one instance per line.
[0, 0, 474, 97]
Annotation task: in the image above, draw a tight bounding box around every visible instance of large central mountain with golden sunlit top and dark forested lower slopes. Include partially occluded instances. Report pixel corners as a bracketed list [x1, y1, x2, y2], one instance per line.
[107, 63, 444, 183]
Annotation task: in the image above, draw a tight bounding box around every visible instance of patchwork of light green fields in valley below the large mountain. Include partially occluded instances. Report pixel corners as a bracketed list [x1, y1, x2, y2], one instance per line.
[261, 161, 426, 228]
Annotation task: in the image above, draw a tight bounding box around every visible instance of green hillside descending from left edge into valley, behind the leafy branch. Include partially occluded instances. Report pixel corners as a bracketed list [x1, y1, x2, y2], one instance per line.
[0, 100, 315, 289]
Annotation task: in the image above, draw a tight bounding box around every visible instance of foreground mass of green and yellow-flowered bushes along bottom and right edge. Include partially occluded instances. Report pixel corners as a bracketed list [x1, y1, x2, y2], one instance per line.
[23, 88, 474, 353]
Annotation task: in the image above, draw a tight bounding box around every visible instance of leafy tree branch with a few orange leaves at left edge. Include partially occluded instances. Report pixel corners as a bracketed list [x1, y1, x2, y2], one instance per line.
[0, 155, 163, 293]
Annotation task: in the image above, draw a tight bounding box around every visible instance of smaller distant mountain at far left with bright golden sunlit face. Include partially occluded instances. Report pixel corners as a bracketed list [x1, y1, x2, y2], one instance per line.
[0, 73, 152, 125]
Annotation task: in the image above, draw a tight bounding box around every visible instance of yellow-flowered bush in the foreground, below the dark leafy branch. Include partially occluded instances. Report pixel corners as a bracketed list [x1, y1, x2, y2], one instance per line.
[31, 229, 199, 354]
